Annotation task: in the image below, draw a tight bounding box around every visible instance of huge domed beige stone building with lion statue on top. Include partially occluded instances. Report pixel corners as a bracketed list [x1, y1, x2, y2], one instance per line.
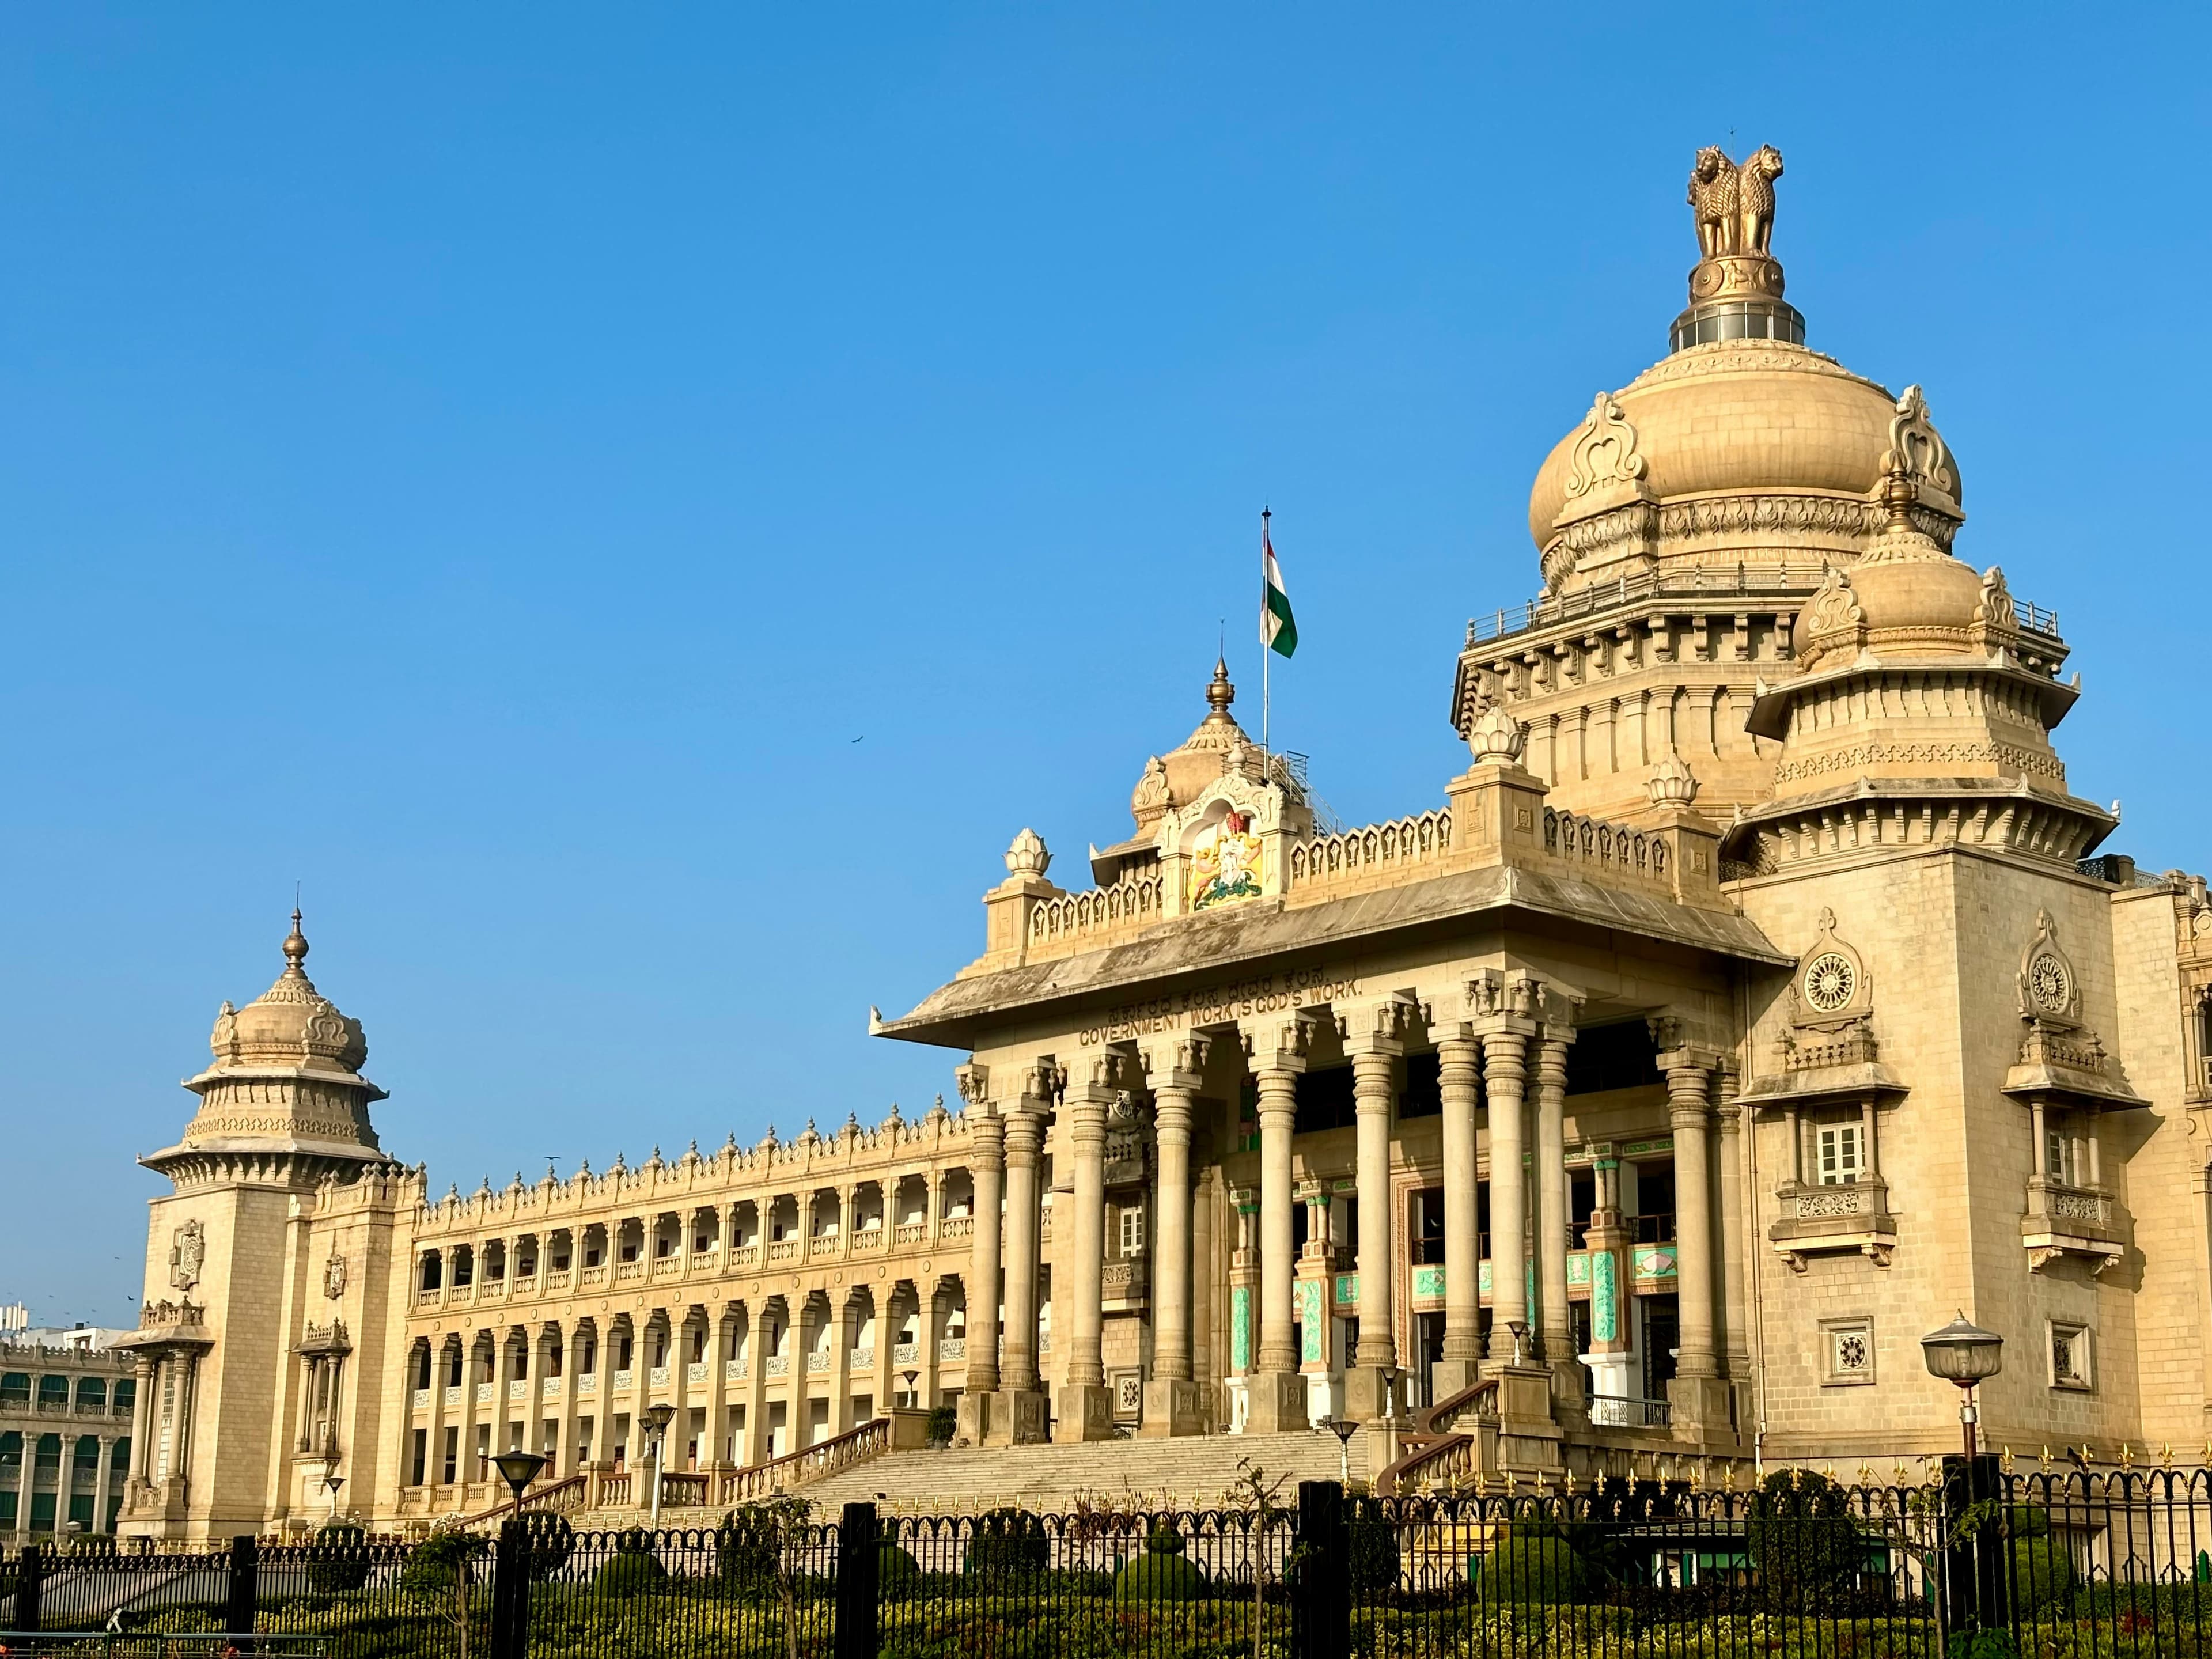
[112, 148, 2212, 1535]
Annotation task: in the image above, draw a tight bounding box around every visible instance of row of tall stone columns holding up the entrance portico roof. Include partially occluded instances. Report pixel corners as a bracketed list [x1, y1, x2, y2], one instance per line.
[962, 971, 1749, 1442]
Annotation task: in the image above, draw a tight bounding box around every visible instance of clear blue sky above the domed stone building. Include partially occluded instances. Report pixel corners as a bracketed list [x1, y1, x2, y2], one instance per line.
[0, 5, 2212, 1323]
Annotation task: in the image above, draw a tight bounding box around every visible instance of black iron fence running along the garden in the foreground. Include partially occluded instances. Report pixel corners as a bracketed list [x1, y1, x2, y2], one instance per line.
[0, 1460, 2212, 1659]
